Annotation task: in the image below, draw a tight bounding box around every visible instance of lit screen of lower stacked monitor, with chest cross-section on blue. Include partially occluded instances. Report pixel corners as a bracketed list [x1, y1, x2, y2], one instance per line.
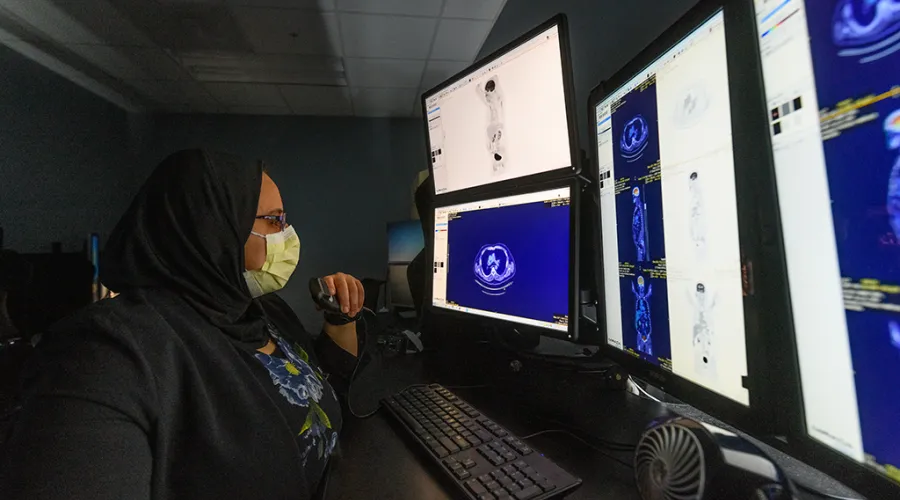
[432, 187, 572, 332]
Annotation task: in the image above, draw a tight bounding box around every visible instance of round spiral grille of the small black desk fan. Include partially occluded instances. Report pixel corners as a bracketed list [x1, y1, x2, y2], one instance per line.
[634, 424, 705, 500]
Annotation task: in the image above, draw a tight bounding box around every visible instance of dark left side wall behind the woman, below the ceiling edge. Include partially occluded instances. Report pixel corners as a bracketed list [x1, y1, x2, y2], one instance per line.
[0, 45, 144, 252]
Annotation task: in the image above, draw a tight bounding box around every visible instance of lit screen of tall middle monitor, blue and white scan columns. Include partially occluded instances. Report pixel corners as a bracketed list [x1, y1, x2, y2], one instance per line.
[594, 11, 749, 405]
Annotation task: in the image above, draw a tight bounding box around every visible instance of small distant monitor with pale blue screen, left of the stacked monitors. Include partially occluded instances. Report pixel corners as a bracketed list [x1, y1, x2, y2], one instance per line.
[387, 220, 425, 309]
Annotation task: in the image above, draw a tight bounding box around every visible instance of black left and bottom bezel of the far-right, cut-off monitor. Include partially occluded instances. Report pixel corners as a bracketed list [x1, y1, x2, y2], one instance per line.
[748, 1, 900, 498]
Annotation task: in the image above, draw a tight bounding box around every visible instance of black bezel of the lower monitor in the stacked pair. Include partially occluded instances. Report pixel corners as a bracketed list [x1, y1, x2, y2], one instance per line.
[428, 178, 582, 342]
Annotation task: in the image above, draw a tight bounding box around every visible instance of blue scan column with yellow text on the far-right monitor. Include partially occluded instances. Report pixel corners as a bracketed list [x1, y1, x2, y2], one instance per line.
[806, 0, 900, 476]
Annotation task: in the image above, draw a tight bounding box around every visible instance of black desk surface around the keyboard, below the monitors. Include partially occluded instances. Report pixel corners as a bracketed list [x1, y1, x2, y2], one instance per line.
[325, 356, 844, 500]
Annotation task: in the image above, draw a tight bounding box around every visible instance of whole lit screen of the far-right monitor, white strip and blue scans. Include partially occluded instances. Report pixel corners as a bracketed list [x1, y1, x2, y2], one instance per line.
[755, 0, 900, 482]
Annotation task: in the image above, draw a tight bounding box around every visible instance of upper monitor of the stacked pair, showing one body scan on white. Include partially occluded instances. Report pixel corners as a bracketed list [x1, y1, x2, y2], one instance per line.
[422, 15, 579, 195]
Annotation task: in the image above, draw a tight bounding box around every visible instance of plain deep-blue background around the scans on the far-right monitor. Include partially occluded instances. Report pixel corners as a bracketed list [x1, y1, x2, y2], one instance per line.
[797, 0, 900, 467]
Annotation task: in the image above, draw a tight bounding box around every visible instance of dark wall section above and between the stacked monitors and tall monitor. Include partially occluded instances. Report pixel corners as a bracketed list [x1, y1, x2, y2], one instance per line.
[479, 0, 697, 149]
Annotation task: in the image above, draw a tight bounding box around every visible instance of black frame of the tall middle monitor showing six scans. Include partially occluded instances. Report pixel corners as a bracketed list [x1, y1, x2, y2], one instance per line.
[588, 0, 776, 436]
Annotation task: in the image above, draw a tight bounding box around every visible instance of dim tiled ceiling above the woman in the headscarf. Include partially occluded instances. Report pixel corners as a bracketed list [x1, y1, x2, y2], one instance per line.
[0, 0, 506, 116]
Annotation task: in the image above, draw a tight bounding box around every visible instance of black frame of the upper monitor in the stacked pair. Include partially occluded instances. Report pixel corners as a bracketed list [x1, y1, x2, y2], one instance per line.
[421, 13, 581, 203]
